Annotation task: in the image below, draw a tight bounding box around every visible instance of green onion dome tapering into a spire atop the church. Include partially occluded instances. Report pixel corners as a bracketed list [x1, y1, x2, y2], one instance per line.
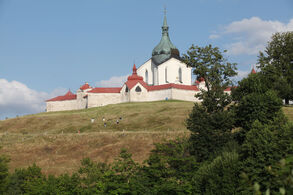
[152, 14, 179, 65]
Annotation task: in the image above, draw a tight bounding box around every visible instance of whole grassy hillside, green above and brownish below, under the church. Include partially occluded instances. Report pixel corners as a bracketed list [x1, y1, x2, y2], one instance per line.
[0, 101, 293, 174]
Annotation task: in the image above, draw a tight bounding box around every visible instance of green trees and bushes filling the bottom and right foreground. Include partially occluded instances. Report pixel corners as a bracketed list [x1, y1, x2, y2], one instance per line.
[0, 32, 293, 195]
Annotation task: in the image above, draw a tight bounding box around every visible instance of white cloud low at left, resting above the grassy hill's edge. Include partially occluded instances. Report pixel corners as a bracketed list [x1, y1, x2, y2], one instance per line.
[0, 79, 65, 119]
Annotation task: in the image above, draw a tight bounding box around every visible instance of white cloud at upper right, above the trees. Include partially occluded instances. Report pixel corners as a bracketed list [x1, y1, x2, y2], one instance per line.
[210, 17, 293, 55]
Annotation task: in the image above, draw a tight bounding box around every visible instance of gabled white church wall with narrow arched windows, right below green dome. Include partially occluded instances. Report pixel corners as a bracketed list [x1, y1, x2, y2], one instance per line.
[158, 58, 191, 85]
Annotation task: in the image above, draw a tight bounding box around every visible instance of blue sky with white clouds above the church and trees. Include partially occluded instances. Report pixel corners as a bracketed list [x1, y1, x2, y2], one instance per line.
[0, 0, 293, 119]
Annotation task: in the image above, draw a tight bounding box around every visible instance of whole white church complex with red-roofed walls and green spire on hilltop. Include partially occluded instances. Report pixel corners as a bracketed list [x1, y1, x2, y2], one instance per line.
[46, 14, 212, 112]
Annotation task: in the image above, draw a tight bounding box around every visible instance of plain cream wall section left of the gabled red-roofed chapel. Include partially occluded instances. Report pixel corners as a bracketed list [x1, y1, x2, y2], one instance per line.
[88, 93, 121, 108]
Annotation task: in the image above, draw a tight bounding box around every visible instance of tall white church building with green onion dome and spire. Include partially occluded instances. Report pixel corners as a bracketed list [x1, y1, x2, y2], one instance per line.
[137, 9, 192, 85]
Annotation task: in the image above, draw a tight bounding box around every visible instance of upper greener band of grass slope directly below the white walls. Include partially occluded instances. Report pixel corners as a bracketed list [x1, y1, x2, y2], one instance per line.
[0, 101, 193, 133]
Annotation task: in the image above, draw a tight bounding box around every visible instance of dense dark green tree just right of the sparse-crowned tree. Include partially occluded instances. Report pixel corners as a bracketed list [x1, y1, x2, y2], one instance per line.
[232, 73, 286, 144]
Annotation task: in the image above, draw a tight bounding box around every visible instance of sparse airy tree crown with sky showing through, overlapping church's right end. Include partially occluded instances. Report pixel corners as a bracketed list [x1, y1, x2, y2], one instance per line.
[182, 45, 237, 113]
